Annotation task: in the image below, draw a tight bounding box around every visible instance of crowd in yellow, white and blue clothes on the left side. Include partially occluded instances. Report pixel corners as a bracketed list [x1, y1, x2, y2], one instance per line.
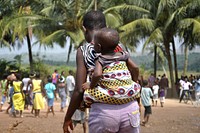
[0, 70, 75, 118]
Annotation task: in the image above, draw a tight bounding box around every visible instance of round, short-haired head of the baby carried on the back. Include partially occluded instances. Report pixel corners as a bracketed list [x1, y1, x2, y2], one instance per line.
[94, 28, 119, 53]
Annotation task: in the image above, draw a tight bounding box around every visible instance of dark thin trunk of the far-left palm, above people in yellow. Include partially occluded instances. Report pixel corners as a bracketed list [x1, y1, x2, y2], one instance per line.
[26, 32, 33, 72]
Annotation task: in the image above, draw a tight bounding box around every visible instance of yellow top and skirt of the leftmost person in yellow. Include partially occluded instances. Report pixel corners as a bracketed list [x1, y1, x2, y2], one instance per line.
[12, 81, 25, 110]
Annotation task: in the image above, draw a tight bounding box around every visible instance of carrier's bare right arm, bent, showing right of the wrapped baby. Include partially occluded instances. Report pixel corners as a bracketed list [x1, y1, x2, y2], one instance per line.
[126, 57, 139, 82]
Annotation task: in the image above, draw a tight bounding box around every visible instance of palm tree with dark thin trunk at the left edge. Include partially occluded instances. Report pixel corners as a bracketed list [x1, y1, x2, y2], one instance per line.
[0, 0, 39, 71]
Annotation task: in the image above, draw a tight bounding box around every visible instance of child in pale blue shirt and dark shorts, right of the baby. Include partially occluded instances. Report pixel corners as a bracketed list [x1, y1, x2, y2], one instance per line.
[141, 80, 153, 126]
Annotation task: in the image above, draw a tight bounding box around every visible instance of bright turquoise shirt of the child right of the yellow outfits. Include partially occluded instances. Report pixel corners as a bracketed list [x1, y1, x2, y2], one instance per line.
[44, 83, 56, 99]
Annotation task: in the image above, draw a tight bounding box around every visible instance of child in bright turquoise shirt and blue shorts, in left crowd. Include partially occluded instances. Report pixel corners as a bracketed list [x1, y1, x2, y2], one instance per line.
[44, 76, 56, 117]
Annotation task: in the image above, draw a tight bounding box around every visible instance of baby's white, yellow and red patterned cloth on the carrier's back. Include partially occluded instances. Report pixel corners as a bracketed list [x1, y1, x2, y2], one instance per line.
[84, 52, 141, 105]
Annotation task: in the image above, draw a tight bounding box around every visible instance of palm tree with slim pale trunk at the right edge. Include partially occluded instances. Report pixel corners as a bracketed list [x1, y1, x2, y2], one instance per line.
[178, 0, 200, 75]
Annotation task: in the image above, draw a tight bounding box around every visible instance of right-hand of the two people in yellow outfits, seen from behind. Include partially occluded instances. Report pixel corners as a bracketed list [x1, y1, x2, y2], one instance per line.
[28, 72, 45, 118]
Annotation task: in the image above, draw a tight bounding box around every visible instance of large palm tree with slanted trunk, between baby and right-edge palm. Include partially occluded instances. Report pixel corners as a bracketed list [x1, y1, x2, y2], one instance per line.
[117, 0, 200, 96]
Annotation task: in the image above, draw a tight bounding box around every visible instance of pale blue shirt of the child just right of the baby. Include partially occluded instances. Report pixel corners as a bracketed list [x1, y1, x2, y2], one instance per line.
[141, 87, 153, 106]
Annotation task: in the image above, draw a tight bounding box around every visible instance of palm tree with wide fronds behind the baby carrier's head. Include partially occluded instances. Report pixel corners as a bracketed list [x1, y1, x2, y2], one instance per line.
[27, 0, 150, 63]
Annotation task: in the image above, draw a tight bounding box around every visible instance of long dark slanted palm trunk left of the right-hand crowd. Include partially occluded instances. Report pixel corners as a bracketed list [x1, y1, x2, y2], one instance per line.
[164, 38, 175, 97]
